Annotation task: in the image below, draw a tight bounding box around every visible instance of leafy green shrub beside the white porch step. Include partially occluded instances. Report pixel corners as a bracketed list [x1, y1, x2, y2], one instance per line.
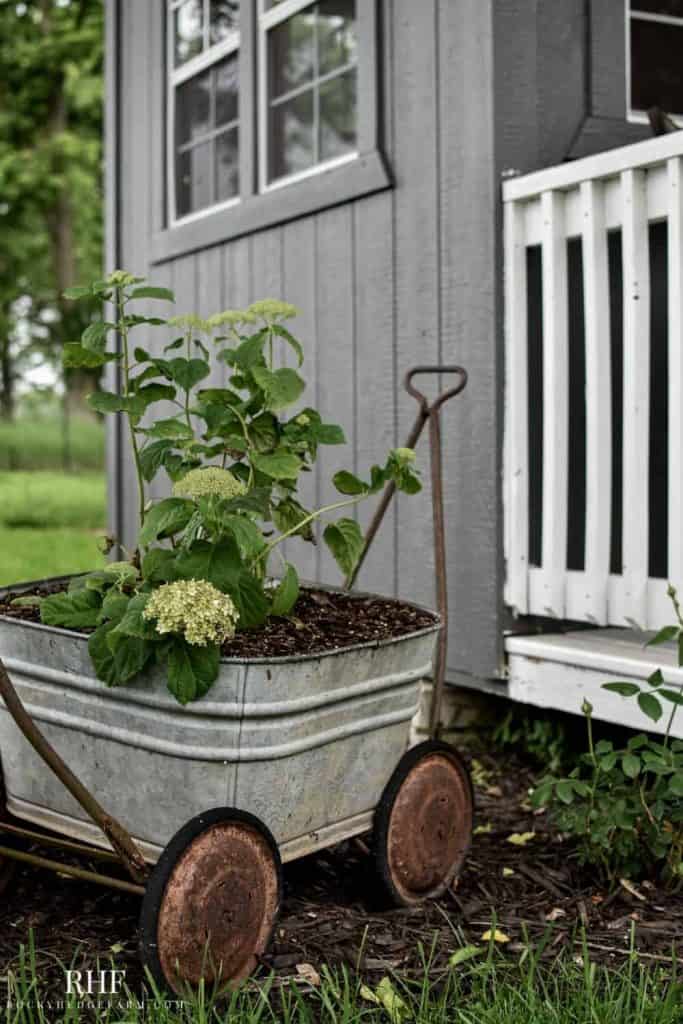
[531, 586, 683, 882]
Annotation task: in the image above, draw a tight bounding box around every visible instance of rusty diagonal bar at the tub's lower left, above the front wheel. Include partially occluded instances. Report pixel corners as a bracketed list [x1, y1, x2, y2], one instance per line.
[0, 658, 148, 885]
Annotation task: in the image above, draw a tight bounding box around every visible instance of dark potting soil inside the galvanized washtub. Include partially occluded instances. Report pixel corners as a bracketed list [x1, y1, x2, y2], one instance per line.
[0, 584, 436, 657]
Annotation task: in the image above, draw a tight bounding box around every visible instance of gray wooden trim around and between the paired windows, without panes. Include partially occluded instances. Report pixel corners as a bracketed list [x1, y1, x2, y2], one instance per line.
[150, 0, 393, 265]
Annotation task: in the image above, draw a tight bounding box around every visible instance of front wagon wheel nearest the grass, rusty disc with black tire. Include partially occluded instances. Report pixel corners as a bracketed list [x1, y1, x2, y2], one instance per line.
[140, 807, 282, 992]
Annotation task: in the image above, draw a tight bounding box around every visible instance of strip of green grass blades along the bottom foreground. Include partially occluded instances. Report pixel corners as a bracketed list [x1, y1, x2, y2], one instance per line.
[0, 945, 683, 1024]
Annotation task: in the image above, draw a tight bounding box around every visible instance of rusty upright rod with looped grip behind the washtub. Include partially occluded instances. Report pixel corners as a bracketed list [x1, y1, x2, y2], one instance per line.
[404, 367, 467, 738]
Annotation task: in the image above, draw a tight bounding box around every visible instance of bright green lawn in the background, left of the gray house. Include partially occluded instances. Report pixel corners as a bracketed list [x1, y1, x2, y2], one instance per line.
[0, 472, 106, 586]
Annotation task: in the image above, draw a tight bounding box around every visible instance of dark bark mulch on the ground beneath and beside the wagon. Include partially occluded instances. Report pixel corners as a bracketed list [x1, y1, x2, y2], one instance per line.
[0, 755, 683, 992]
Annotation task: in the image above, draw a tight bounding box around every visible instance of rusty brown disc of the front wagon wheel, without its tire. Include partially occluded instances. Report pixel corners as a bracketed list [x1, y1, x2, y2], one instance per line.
[157, 821, 280, 989]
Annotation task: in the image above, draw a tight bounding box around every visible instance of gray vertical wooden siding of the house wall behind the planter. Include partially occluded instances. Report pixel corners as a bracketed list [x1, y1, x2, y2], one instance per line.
[112, 0, 511, 680]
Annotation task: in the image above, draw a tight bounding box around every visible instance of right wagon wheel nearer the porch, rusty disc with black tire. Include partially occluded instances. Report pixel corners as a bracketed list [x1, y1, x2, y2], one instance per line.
[373, 740, 474, 906]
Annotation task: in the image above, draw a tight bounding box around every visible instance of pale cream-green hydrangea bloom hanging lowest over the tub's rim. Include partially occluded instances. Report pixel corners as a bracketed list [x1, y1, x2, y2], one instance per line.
[142, 580, 240, 647]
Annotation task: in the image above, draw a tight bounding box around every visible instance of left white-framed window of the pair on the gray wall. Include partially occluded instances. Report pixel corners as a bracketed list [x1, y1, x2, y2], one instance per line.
[167, 0, 240, 225]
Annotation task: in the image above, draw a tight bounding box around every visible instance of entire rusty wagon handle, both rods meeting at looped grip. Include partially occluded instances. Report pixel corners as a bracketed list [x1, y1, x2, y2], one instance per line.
[344, 366, 468, 738]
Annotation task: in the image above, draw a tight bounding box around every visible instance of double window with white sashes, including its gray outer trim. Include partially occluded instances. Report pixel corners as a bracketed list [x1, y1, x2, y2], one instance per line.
[159, 0, 385, 251]
